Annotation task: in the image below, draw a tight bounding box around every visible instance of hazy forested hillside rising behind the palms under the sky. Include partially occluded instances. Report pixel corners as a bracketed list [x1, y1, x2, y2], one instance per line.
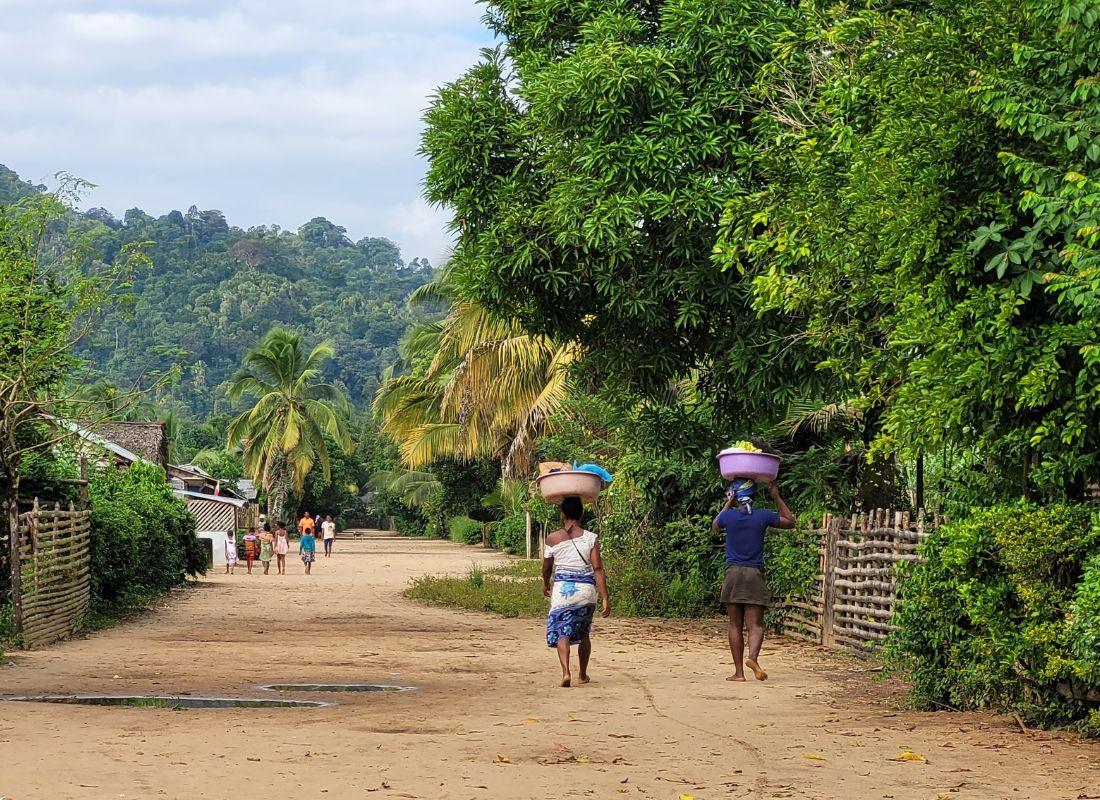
[0, 165, 432, 418]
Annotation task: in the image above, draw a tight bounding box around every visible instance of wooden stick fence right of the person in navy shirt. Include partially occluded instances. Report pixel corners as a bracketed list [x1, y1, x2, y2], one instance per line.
[781, 508, 939, 654]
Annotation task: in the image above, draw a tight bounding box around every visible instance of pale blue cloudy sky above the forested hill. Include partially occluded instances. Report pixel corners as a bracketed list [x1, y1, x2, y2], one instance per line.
[0, 0, 492, 262]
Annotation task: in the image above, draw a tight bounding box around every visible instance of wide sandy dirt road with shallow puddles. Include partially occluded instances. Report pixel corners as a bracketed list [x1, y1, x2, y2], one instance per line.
[0, 538, 1100, 800]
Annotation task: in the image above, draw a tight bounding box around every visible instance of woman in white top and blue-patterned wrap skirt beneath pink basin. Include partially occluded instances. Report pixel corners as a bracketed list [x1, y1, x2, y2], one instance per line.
[542, 497, 612, 687]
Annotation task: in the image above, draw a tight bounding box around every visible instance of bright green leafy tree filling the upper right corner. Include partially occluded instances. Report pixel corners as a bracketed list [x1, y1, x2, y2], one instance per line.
[718, 0, 1100, 496]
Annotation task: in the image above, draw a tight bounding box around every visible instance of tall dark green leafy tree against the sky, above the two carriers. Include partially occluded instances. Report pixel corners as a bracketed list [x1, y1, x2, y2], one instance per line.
[422, 0, 814, 419]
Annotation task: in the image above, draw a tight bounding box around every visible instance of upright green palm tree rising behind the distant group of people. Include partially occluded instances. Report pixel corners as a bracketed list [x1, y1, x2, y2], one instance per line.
[228, 328, 352, 518]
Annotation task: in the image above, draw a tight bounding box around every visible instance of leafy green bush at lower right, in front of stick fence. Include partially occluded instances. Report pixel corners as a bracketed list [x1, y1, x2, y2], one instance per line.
[887, 504, 1100, 734]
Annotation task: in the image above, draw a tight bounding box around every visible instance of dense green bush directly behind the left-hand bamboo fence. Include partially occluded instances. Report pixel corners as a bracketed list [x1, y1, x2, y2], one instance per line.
[89, 462, 206, 614]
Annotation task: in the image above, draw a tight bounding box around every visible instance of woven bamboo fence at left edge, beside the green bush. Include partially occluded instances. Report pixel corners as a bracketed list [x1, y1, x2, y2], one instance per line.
[10, 500, 91, 647]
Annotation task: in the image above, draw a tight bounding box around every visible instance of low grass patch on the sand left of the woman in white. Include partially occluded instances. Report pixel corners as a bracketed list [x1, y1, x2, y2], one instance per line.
[405, 566, 547, 616]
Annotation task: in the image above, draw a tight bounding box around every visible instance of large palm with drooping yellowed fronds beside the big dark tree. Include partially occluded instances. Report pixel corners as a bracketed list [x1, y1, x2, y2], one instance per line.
[374, 272, 579, 475]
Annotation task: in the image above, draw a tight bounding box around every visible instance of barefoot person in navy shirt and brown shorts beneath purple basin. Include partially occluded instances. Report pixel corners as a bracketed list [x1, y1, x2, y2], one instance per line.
[712, 479, 795, 681]
